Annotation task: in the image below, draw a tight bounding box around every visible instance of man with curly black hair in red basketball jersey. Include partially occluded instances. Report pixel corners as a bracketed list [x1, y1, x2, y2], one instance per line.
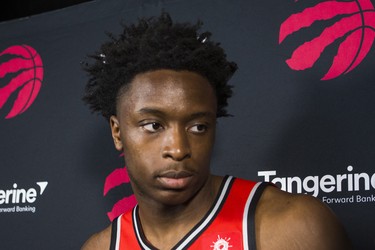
[82, 13, 350, 250]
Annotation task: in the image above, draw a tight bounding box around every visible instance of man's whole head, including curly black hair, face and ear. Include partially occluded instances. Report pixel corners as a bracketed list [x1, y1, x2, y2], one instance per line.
[84, 13, 236, 205]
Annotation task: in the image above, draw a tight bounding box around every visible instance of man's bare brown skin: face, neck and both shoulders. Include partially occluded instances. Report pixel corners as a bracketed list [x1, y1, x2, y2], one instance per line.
[82, 70, 350, 250]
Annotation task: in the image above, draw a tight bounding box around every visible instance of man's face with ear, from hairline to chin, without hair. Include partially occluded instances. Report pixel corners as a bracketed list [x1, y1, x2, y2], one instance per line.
[111, 70, 217, 205]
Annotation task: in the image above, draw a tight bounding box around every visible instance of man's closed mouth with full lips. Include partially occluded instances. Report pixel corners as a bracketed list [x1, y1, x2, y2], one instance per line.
[157, 170, 193, 190]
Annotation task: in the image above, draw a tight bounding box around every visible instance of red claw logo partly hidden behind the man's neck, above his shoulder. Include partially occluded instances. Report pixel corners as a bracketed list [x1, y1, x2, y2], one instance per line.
[104, 154, 137, 221]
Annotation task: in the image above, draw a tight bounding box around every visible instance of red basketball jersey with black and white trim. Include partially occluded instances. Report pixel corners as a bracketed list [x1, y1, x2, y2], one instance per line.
[111, 176, 267, 250]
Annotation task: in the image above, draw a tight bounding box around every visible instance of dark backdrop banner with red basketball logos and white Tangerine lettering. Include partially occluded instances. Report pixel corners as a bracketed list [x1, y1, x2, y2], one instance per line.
[0, 0, 375, 250]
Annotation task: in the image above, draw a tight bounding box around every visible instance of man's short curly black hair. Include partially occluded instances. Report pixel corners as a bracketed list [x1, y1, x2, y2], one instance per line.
[83, 13, 237, 119]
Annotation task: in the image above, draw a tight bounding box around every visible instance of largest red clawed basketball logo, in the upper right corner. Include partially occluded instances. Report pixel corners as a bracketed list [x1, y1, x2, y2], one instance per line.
[279, 0, 375, 80]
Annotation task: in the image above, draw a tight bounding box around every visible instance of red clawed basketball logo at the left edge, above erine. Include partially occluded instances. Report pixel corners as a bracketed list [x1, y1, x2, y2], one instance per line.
[0, 45, 43, 119]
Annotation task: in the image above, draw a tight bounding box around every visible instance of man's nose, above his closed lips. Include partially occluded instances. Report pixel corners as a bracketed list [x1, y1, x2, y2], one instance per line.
[163, 128, 191, 161]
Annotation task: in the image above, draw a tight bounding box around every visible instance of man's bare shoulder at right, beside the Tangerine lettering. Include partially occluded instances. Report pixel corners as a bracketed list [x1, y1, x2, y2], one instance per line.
[255, 187, 351, 250]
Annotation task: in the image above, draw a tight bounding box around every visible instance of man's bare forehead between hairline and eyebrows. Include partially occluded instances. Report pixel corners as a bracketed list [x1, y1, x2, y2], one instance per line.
[118, 70, 217, 115]
